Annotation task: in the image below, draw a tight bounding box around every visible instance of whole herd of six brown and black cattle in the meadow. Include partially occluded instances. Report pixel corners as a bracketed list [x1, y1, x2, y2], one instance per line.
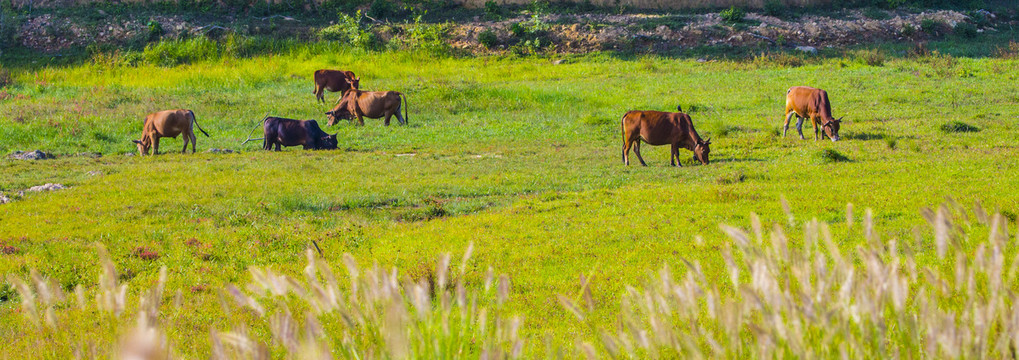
[133, 69, 842, 166]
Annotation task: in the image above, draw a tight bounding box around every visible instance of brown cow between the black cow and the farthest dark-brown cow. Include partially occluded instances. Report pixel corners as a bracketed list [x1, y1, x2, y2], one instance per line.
[325, 89, 410, 126]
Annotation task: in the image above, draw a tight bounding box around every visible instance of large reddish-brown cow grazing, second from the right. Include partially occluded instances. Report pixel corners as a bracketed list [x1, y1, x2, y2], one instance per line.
[622, 111, 711, 166]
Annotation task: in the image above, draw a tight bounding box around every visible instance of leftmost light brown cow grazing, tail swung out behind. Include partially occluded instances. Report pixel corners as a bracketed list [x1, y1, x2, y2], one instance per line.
[132, 109, 209, 155]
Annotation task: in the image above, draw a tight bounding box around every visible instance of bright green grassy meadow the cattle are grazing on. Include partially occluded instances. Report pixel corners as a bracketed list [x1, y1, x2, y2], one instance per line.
[0, 42, 1019, 358]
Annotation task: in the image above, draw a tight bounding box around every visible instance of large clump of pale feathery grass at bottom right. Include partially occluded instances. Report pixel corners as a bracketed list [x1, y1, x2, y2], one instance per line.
[559, 200, 1019, 358]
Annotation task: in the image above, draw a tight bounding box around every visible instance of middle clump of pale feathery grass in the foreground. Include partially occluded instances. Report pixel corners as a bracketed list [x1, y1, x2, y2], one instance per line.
[219, 242, 525, 359]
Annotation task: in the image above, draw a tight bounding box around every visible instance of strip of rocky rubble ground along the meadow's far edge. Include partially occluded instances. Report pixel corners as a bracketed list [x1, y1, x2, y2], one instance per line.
[9, 9, 1006, 53]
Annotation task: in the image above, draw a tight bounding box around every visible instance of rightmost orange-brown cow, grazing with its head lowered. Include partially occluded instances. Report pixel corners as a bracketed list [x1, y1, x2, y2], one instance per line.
[782, 87, 842, 142]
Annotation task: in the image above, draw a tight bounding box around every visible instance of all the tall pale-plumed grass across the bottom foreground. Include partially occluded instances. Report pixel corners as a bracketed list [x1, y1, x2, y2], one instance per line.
[8, 202, 1019, 359]
